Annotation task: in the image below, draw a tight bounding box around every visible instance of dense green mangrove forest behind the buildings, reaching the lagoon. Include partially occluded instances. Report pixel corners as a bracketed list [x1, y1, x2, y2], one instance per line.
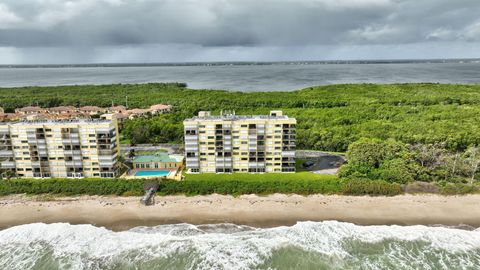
[0, 83, 480, 152]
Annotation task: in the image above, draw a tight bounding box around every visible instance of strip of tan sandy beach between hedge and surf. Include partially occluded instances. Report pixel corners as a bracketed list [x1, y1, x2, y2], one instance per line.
[0, 194, 480, 230]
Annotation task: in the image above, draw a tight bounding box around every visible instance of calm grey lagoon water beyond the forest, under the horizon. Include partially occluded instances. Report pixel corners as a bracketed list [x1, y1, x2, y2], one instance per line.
[0, 61, 480, 92]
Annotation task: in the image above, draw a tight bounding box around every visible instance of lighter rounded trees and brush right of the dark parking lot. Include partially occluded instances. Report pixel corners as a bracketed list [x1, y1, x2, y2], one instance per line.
[339, 139, 480, 191]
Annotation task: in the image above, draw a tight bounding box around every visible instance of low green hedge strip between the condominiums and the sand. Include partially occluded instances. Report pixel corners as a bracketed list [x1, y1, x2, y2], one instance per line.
[0, 177, 401, 196]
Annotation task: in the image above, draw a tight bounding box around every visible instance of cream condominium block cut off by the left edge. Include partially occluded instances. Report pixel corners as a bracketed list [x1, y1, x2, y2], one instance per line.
[0, 115, 119, 177]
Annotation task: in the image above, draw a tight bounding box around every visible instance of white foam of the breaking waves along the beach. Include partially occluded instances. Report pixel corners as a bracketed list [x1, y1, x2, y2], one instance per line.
[0, 221, 480, 269]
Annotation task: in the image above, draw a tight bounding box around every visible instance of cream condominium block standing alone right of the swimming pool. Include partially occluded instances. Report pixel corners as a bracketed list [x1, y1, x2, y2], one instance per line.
[183, 111, 297, 173]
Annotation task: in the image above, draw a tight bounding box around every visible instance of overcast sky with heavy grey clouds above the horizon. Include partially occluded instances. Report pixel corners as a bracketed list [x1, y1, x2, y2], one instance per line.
[0, 0, 480, 64]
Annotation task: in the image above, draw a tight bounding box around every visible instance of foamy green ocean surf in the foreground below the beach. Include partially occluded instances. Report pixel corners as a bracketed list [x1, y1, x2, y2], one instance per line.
[0, 221, 480, 270]
